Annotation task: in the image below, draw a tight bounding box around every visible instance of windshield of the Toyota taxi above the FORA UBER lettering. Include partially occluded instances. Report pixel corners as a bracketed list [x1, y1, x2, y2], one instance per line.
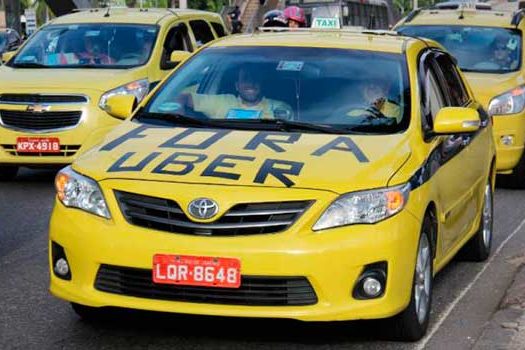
[143, 47, 410, 133]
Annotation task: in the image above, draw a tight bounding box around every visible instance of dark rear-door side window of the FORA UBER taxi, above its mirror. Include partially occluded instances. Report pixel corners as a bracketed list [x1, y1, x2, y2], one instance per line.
[436, 53, 470, 107]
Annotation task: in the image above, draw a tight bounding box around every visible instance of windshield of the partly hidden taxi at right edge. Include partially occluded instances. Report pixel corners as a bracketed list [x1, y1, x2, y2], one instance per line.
[398, 25, 521, 73]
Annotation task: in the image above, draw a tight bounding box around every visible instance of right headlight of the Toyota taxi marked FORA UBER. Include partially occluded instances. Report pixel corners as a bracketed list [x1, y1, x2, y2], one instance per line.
[313, 184, 410, 231]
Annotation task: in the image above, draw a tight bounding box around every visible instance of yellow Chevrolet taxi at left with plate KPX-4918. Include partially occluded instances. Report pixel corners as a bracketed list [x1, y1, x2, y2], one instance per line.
[0, 9, 226, 181]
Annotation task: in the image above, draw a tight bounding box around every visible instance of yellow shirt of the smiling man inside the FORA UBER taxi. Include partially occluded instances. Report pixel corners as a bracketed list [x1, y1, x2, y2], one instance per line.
[191, 93, 293, 119]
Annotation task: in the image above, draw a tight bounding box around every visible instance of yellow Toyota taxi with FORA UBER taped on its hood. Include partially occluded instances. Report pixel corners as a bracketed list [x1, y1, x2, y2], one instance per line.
[49, 31, 495, 340]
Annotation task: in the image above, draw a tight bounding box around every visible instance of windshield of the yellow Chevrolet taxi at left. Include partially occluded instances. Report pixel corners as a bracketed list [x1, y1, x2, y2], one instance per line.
[11, 24, 157, 68]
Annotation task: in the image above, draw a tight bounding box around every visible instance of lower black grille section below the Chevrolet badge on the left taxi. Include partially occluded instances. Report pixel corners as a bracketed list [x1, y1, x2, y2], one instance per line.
[0, 110, 82, 131]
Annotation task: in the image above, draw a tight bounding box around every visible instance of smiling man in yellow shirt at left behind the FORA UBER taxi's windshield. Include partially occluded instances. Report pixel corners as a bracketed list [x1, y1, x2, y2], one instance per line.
[184, 64, 293, 119]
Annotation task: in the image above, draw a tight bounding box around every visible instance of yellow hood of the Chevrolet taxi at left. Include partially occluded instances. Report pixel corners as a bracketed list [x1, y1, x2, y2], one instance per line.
[0, 66, 146, 93]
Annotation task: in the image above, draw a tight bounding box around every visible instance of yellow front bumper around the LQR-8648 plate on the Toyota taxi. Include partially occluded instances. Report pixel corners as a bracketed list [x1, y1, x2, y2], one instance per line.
[50, 185, 420, 321]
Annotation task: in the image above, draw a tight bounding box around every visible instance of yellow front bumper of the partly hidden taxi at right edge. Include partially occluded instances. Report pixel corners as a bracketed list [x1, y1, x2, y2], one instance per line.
[493, 114, 525, 172]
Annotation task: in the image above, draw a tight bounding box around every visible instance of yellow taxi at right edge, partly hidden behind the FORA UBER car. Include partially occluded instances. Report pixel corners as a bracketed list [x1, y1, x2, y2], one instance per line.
[396, 9, 525, 188]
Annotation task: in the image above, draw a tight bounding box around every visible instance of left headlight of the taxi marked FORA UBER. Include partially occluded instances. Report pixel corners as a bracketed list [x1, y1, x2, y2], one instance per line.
[55, 166, 111, 219]
